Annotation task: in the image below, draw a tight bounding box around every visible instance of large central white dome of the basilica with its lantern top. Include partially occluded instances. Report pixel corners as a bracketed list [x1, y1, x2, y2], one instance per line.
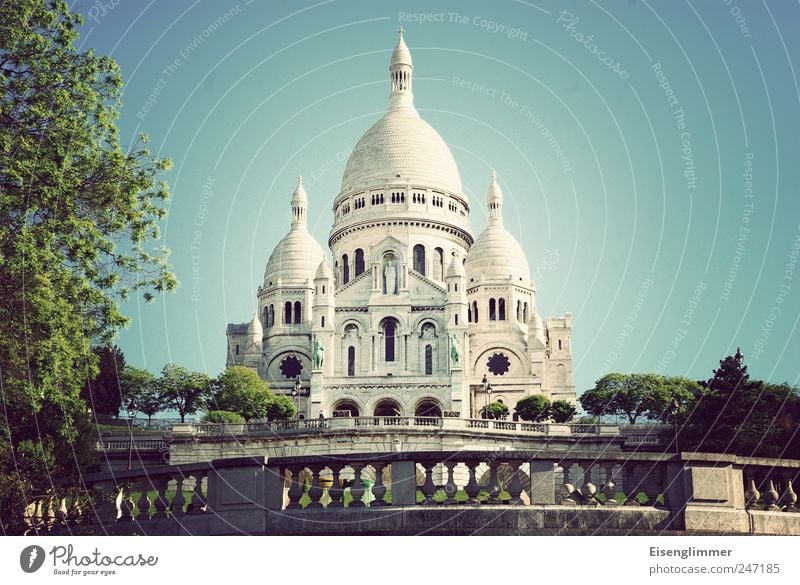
[341, 29, 462, 196]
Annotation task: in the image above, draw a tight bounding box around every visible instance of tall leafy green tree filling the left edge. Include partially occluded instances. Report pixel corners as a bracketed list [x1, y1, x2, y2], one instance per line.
[0, 0, 176, 533]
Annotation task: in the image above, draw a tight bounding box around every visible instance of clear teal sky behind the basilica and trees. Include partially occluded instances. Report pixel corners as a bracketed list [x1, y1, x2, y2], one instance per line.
[76, 0, 800, 393]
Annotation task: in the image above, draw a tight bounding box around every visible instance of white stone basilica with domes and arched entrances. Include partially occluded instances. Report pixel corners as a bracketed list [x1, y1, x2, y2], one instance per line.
[227, 32, 575, 417]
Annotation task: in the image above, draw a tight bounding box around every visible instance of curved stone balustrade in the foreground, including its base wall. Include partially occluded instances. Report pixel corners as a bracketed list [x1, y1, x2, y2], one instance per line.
[25, 450, 800, 535]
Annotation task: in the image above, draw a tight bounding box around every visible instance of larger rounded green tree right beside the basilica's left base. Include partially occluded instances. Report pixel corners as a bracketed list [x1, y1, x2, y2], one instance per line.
[210, 366, 275, 420]
